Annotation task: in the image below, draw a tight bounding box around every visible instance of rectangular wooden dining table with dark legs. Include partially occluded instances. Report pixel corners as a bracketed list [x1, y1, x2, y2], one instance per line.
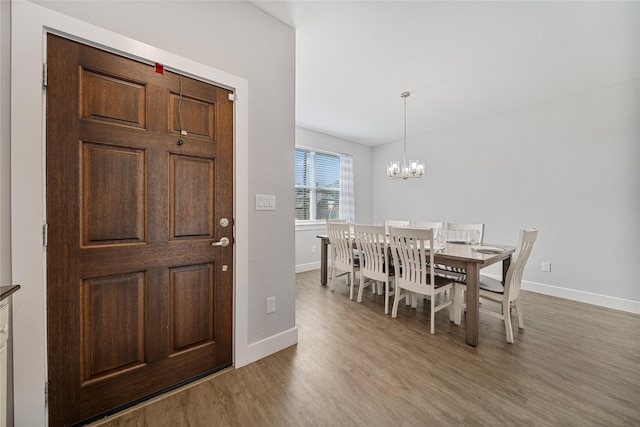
[317, 234, 516, 346]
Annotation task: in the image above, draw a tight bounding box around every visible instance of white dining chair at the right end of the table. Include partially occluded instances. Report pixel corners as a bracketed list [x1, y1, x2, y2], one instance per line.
[454, 229, 538, 343]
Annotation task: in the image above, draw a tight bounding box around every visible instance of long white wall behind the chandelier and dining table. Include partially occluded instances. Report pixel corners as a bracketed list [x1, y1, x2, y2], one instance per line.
[372, 80, 640, 313]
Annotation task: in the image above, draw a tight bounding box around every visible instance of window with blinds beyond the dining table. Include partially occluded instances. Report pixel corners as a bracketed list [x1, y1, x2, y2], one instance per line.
[295, 148, 353, 221]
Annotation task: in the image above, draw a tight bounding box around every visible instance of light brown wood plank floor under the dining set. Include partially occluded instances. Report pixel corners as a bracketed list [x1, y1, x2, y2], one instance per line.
[94, 271, 640, 427]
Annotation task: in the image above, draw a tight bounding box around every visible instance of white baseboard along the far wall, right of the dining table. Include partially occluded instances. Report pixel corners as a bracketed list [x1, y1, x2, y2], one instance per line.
[487, 274, 640, 314]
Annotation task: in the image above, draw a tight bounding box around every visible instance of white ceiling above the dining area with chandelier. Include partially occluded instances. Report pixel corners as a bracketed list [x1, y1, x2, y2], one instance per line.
[251, 1, 640, 146]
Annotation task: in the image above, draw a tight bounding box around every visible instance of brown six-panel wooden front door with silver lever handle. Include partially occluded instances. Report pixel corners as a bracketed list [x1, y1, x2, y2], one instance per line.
[46, 35, 233, 426]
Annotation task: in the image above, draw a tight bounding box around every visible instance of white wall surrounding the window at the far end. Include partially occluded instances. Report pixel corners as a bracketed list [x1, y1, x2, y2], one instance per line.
[291, 127, 373, 272]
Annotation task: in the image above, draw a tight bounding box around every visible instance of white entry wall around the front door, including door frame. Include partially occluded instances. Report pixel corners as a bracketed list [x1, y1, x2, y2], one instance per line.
[9, 1, 297, 426]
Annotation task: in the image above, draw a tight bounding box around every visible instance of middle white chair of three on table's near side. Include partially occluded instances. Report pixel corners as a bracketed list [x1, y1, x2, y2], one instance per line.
[355, 224, 395, 314]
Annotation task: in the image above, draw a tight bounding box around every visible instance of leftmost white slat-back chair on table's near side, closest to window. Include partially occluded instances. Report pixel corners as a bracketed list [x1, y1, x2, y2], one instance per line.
[327, 222, 360, 299]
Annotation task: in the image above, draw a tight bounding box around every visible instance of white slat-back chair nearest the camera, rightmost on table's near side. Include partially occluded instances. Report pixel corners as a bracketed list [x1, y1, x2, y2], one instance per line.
[389, 227, 455, 334]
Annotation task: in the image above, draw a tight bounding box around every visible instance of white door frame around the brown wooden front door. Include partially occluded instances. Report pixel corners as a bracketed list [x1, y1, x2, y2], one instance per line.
[11, 1, 252, 425]
